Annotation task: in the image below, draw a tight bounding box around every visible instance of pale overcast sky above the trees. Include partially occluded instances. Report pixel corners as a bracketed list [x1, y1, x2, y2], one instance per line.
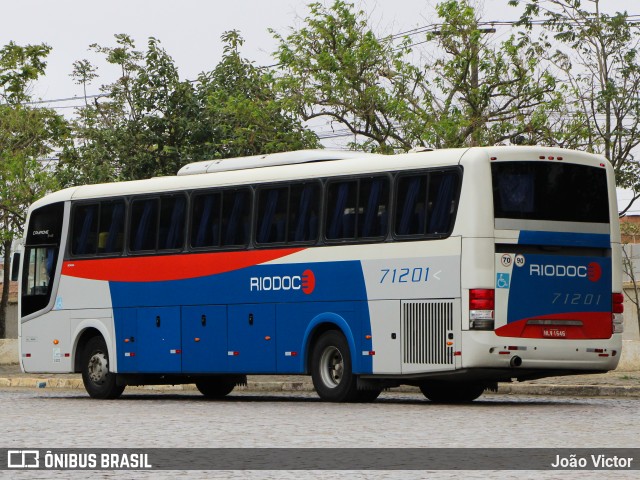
[0, 0, 640, 211]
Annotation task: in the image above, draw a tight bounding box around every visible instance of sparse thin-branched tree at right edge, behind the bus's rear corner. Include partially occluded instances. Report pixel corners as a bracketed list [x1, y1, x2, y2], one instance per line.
[510, 0, 640, 214]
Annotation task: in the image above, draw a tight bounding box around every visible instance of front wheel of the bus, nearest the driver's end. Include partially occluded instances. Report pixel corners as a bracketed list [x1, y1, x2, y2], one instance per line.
[82, 336, 125, 400]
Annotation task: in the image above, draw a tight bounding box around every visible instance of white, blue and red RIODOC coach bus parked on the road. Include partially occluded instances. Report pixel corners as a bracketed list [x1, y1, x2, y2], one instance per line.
[20, 147, 623, 402]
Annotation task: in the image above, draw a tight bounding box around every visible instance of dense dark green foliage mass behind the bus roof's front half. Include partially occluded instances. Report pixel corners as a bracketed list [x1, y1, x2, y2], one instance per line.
[60, 31, 318, 184]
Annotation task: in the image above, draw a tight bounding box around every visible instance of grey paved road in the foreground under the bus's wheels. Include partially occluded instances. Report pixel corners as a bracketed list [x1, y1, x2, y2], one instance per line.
[0, 388, 640, 479]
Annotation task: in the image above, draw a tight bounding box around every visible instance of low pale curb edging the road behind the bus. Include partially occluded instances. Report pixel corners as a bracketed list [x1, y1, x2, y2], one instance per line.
[0, 377, 640, 398]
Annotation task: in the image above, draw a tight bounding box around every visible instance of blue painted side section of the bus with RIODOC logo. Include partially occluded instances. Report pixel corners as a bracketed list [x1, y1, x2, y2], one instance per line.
[109, 261, 373, 374]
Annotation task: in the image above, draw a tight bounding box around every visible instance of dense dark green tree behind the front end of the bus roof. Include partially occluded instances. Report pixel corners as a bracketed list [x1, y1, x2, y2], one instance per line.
[61, 34, 197, 184]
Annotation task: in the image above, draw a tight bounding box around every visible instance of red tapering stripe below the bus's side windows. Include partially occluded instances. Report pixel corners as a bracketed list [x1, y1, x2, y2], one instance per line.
[62, 248, 304, 282]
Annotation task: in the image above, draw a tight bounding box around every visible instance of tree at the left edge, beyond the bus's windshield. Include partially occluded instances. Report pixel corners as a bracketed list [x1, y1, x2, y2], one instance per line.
[0, 42, 67, 338]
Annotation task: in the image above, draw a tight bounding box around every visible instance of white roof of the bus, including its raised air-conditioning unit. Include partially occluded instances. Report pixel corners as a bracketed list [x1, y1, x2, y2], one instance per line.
[34, 146, 606, 207]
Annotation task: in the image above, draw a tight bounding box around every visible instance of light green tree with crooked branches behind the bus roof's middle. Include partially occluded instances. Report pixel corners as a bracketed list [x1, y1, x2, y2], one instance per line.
[272, 0, 420, 152]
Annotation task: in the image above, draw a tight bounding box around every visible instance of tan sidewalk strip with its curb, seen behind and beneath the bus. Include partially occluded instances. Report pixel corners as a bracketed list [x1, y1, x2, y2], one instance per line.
[0, 364, 640, 398]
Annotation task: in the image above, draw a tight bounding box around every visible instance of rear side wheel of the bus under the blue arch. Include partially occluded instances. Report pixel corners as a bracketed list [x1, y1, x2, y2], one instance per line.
[311, 330, 360, 402]
